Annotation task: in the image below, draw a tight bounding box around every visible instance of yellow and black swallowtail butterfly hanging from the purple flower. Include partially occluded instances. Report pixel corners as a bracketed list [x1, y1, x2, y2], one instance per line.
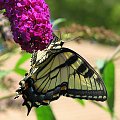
[16, 35, 107, 115]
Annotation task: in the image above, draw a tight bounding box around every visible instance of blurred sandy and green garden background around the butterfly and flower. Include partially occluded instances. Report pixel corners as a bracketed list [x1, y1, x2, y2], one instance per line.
[0, 0, 120, 120]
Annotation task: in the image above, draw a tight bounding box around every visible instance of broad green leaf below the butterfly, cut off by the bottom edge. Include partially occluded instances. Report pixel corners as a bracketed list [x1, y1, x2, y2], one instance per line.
[35, 106, 56, 120]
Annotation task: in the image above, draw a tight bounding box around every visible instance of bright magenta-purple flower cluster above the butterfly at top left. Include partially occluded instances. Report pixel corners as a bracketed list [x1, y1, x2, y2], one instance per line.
[0, 0, 53, 53]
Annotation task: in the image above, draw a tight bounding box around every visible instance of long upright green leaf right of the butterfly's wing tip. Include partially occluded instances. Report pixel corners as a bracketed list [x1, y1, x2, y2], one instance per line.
[103, 61, 115, 116]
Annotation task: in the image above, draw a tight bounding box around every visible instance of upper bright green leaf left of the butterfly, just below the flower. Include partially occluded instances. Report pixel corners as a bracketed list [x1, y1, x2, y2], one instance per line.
[15, 53, 31, 68]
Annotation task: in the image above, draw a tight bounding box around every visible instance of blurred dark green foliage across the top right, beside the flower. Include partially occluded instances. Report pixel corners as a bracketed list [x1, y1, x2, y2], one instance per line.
[46, 0, 120, 33]
